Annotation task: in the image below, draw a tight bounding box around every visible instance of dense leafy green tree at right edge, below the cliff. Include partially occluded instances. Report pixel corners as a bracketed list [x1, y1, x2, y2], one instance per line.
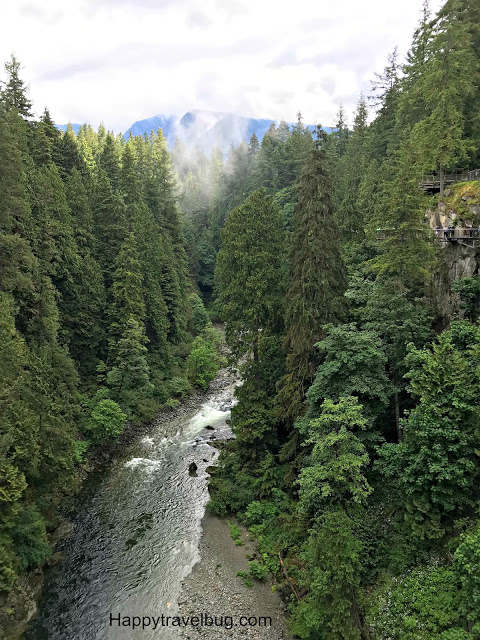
[383, 332, 479, 538]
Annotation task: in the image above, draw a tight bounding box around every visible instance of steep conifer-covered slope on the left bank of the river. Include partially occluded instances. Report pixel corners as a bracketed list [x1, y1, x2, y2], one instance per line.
[0, 58, 220, 591]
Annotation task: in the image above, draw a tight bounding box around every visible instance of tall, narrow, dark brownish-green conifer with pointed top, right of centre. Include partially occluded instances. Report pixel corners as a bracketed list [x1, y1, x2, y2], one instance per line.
[279, 128, 346, 420]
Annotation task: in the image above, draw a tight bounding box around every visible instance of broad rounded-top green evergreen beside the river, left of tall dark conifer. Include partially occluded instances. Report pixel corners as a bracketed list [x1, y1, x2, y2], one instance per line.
[215, 189, 285, 467]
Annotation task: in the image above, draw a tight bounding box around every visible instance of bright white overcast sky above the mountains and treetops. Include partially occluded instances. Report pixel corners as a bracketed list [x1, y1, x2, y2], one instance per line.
[0, 0, 443, 132]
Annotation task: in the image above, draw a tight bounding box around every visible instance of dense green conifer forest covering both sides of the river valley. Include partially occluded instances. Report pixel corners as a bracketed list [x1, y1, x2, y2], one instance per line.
[0, 0, 480, 640]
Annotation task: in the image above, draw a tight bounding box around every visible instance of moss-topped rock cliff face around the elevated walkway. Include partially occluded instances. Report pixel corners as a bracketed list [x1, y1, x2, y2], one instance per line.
[426, 181, 480, 324]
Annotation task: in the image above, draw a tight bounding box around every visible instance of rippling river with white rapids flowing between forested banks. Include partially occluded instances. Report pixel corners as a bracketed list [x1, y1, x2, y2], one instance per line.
[25, 375, 235, 640]
